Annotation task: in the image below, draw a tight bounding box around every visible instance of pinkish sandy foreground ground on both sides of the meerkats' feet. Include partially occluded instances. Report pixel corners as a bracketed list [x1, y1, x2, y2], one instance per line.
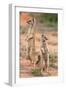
[20, 59, 58, 78]
